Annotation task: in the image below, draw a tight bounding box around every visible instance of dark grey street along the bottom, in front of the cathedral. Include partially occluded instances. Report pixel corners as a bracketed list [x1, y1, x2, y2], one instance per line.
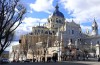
[1, 61, 100, 65]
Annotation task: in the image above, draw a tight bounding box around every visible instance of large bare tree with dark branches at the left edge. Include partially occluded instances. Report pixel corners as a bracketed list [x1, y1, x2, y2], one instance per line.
[0, 0, 26, 55]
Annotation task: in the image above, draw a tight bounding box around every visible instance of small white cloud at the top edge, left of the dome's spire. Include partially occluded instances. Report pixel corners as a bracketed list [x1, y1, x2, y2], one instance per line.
[30, 0, 54, 14]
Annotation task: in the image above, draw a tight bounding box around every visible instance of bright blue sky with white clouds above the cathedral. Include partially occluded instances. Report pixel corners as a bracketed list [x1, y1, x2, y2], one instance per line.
[5, 0, 100, 50]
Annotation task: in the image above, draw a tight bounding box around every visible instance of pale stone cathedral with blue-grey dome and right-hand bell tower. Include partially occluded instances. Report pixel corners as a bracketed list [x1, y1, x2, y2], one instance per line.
[21, 4, 100, 61]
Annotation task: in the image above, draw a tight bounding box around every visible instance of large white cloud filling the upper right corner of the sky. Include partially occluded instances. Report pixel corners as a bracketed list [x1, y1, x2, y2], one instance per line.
[60, 0, 100, 23]
